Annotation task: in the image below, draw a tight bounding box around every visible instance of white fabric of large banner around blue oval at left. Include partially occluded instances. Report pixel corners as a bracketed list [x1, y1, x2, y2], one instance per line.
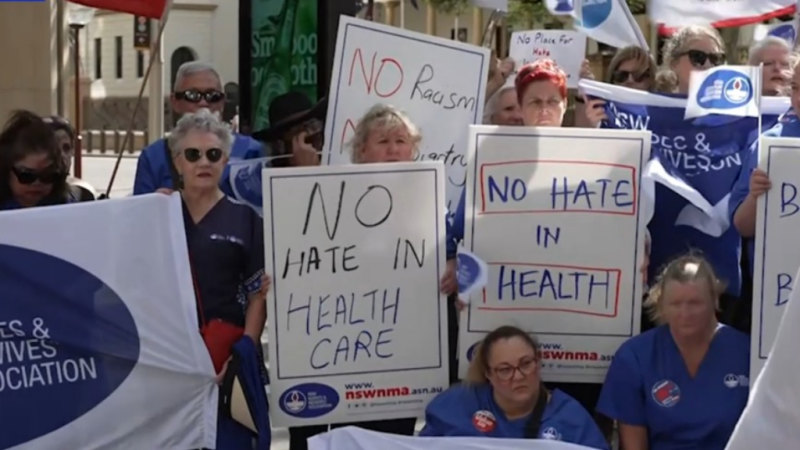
[0, 194, 218, 450]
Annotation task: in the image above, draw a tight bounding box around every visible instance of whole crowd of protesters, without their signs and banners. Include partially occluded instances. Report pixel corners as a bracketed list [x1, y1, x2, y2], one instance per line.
[0, 22, 800, 450]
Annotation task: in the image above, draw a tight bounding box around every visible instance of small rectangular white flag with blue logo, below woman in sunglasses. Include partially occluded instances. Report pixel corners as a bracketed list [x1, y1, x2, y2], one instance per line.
[684, 66, 761, 119]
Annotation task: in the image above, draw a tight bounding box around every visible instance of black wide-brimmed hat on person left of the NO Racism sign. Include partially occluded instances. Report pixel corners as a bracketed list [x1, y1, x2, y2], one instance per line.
[253, 92, 328, 141]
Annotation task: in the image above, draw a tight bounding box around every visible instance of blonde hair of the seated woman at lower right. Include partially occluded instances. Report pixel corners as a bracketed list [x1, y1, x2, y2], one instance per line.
[644, 253, 725, 325]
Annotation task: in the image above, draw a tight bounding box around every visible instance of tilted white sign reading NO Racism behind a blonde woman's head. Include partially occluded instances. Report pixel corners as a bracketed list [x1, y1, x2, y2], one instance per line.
[323, 17, 490, 219]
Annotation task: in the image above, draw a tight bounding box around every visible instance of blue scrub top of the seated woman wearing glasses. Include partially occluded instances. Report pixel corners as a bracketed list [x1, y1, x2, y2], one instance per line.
[420, 384, 608, 449]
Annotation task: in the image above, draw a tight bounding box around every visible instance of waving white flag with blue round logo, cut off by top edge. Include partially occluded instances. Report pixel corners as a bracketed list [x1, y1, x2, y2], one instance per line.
[572, 0, 650, 51]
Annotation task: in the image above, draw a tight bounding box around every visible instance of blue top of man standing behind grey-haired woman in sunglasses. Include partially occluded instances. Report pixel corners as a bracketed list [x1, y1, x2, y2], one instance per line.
[133, 134, 264, 197]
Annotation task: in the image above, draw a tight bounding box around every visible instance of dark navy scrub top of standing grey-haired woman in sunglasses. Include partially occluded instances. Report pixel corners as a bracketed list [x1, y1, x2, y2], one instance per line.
[183, 197, 264, 327]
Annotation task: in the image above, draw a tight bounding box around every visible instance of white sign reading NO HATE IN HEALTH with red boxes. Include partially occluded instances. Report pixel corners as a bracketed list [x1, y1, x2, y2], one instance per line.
[460, 126, 650, 382]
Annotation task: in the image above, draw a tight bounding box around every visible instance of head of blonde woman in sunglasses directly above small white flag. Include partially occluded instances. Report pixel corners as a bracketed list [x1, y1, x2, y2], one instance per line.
[657, 25, 725, 95]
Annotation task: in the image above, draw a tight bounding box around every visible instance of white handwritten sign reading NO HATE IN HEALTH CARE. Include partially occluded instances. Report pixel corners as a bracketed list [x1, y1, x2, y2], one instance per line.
[263, 162, 448, 426]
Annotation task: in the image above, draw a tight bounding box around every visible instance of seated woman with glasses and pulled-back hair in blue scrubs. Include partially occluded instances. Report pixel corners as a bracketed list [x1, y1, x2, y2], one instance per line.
[420, 326, 608, 449]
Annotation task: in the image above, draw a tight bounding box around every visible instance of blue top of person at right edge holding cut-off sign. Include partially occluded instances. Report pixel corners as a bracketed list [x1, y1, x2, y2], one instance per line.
[728, 111, 800, 276]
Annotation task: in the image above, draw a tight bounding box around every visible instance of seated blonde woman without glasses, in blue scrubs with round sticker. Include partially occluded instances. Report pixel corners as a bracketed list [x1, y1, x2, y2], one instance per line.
[597, 255, 750, 450]
